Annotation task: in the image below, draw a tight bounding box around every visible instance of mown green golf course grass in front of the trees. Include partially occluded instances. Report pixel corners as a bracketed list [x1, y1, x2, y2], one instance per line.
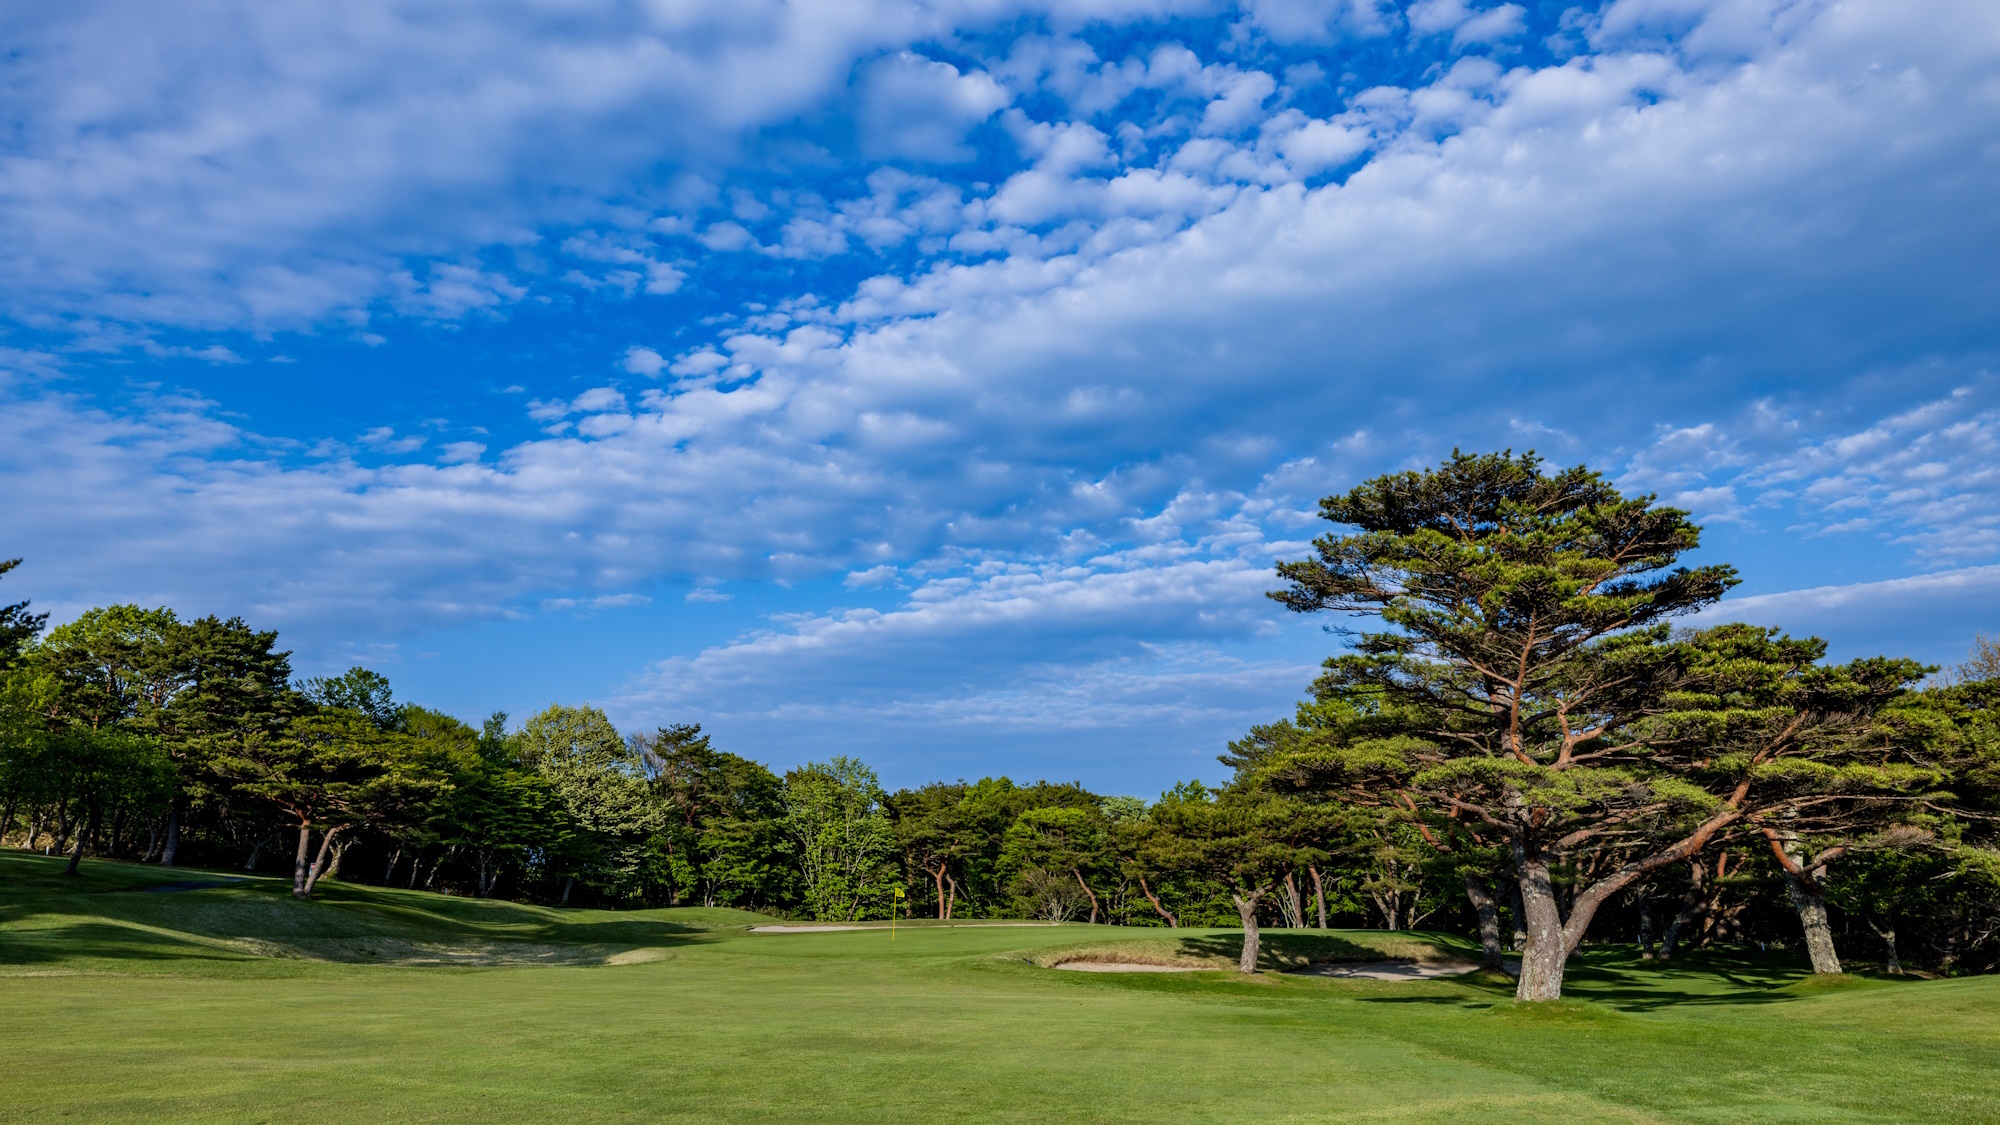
[0, 853, 2000, 1125]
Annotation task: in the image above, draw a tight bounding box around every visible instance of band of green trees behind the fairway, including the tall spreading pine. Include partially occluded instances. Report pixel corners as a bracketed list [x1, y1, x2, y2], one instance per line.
[0, 452, 2000, 1001]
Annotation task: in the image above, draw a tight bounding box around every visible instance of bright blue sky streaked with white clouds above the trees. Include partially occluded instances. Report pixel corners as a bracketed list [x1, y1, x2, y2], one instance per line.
[0, 0, 2000, 797]
